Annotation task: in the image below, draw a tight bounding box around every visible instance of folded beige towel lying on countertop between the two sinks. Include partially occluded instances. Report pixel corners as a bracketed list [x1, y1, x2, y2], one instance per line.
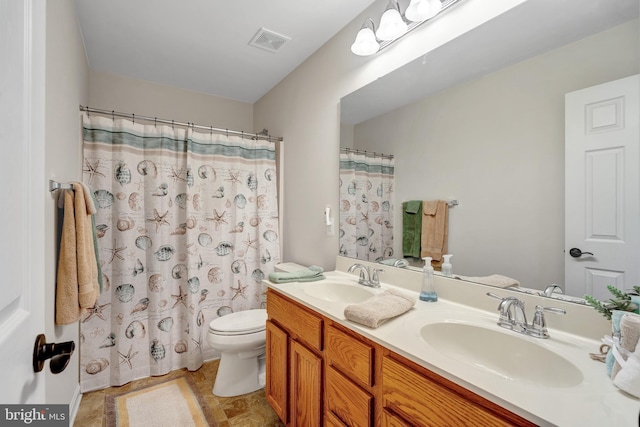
[344, 289, 416, 328]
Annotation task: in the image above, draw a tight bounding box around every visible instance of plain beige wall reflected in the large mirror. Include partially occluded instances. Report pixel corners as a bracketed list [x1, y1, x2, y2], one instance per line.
[354, 19, 640, 289]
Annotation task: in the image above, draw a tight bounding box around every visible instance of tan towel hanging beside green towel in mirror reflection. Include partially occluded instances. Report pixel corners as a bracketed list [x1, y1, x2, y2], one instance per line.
[420, 200, 449, 267]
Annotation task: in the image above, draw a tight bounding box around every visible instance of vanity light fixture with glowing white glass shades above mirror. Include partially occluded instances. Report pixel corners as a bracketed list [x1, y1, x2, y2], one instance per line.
[351, 0, 459, 56]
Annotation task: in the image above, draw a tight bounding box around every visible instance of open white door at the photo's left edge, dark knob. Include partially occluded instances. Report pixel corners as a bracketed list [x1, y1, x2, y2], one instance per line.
[0, 0, 45, 404]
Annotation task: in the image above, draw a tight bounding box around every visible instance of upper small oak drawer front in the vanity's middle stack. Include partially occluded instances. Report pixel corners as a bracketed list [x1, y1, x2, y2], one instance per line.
[325, 325, 374, 387]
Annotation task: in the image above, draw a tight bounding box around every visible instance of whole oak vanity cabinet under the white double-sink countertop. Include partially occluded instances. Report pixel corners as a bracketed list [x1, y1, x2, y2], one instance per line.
[265, 289, 535, 427]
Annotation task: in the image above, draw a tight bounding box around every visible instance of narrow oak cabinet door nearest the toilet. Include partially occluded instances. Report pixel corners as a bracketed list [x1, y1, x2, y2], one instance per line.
[265, 321, 289, 424]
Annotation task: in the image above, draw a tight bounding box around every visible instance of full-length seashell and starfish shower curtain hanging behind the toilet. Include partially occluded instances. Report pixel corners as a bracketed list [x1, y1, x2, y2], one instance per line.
[80, 113, 280, 392]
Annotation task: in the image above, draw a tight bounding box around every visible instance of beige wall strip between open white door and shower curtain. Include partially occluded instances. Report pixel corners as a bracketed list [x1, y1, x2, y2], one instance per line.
[42, 0, 89, 412]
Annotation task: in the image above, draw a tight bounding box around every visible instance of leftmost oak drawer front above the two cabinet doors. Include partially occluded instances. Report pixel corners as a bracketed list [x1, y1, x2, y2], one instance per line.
[267, 289, 322, 351]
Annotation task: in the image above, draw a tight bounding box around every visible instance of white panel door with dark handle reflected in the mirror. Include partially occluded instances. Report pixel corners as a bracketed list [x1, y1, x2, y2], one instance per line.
[565, 75, 640, 300]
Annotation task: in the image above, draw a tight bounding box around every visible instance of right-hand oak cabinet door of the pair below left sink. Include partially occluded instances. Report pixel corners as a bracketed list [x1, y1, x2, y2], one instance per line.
[290, 341, 322, 427]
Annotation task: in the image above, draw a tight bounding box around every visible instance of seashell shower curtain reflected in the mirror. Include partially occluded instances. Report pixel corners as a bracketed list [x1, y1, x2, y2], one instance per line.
[339, 150, 394, 261]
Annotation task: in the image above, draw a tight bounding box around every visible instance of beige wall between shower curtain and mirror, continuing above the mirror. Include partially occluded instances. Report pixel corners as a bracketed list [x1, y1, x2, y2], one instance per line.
[254, 0, 522, 269]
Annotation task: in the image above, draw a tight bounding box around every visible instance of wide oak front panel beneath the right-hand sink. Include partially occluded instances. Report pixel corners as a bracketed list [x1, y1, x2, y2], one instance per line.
[382, 356, 533, 426]
